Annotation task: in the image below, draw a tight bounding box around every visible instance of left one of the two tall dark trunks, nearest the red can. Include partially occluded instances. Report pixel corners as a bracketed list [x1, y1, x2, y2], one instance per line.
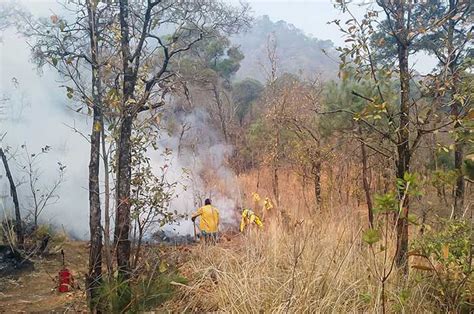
[86, 1, 103, 312]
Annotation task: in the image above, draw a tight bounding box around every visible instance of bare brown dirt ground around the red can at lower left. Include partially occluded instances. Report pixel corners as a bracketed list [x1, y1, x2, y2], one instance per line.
[0, 241, 88, 313]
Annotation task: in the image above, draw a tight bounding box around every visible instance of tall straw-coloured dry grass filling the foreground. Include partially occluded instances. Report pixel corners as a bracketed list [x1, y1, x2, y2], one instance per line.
[166, 212, 436, 313]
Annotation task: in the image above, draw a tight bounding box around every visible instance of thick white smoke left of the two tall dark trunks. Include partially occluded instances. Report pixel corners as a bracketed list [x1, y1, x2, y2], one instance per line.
[0, 30, 90, 238]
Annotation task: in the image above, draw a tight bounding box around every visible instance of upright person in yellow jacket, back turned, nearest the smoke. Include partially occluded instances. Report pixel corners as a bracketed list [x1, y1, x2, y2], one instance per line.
[191, 199, 219, 243]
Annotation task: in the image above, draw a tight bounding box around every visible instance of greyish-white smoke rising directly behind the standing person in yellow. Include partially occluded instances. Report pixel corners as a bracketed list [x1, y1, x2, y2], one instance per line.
[155, 109, 240, 234]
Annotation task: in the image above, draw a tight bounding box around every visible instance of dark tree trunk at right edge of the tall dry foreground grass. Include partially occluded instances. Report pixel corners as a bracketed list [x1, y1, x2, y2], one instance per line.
[395, 28, 410, 273]
